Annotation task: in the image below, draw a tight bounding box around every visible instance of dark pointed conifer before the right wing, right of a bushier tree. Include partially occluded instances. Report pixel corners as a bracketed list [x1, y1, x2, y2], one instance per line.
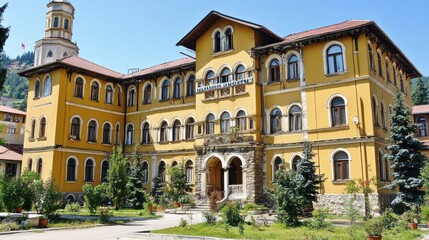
[298, 142, 325, 207]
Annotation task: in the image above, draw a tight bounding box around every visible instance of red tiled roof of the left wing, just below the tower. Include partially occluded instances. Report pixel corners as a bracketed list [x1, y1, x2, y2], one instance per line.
[58, 55, 124, 78]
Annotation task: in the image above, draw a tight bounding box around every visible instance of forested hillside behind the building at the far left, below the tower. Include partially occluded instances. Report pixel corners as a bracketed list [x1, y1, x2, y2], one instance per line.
[0, 52, 34, 111]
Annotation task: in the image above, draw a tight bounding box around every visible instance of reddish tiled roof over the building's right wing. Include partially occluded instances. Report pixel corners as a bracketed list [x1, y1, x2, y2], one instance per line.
[284, 20, 372, 42]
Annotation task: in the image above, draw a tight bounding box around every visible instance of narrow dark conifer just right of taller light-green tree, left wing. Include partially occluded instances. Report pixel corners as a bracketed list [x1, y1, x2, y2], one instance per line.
[127, 151, 147, 209]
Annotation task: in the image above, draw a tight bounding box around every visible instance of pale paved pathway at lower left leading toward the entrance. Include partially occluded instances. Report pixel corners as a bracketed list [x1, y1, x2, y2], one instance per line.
[0, 213, 203, 240]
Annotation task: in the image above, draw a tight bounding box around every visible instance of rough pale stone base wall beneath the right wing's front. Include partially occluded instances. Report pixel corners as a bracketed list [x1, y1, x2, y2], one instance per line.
[315, 193, 380, 216]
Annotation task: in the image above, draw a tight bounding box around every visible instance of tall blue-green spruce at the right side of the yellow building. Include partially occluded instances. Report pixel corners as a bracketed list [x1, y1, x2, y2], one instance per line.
[386, 92, 426, 208]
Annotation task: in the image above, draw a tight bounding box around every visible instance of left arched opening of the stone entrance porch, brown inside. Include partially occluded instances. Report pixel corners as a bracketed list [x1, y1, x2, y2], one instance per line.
[206, 157, 224, 196]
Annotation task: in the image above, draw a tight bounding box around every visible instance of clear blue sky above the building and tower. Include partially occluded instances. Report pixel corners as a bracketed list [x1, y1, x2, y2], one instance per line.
[0, 0, 429, 76]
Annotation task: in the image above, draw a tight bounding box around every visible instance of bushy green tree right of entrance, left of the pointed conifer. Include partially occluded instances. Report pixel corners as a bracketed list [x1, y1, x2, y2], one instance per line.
[268, 166, 307, 227]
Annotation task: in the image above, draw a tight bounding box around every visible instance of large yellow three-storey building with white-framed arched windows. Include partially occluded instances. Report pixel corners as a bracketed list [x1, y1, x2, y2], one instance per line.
[21, 3, 421, 212]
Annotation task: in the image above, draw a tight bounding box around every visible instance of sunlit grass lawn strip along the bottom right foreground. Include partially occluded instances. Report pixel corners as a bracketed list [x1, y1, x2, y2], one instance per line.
[152, 223, 423, 240]
